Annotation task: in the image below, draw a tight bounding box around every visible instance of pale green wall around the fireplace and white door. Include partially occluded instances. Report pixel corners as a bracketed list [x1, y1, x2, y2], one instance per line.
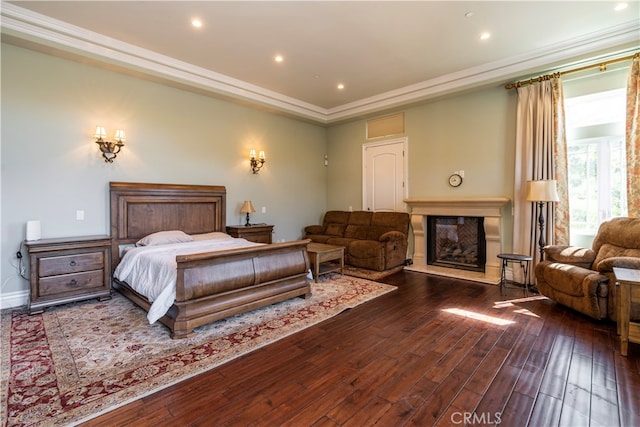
[327, 85, 517, 246]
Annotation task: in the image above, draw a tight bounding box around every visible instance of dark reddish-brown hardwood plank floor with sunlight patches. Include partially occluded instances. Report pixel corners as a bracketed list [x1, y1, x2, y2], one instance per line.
[86, 272, 640, 427]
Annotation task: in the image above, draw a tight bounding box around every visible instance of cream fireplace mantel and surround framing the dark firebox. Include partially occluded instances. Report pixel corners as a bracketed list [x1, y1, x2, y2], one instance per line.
[405, 197, 510, 283]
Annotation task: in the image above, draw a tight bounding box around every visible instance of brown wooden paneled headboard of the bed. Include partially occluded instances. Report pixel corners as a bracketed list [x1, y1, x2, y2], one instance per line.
[109, 182, 227, 269]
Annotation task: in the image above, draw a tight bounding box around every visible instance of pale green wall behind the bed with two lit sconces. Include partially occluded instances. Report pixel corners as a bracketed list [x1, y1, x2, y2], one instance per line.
[0, 43, 327, 299]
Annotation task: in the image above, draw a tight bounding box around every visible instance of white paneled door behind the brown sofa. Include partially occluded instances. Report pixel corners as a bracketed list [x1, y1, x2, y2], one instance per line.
[362, 138, 407, 212]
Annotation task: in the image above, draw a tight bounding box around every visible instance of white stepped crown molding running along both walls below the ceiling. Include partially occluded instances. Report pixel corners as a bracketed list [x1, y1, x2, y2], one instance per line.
[1, 3, 640, 124]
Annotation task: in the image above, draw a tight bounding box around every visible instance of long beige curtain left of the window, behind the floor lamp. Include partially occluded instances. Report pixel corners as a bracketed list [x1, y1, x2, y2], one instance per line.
[513, 74, 569, 280]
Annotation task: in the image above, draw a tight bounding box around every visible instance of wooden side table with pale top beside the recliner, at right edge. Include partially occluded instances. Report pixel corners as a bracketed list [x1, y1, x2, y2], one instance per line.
[613, 267, 640, 356]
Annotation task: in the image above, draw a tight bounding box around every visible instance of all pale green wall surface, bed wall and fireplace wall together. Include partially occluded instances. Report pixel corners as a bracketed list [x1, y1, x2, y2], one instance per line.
[0, 44, 516, 306]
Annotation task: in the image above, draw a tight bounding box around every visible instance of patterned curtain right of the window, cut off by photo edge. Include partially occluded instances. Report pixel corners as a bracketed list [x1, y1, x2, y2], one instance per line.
[626, 53, 640, 218]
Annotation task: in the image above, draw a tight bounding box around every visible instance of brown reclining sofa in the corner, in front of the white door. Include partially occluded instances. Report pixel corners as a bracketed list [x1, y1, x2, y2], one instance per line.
[304, 211, 410, 271]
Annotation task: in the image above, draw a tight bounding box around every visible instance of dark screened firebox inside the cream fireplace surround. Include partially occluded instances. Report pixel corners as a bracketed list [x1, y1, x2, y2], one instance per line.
[427, 215, 487, 272]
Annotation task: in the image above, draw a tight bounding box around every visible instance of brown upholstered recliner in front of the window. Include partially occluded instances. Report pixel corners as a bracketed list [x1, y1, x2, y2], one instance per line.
[535, 218, 640, 321]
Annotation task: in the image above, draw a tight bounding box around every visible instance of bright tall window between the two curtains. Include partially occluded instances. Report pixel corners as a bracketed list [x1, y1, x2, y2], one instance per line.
[565, 89, 627, 246]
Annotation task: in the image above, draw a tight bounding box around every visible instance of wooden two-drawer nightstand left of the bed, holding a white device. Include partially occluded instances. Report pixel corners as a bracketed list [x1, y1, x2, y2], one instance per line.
[25, 236, 111, 314]
